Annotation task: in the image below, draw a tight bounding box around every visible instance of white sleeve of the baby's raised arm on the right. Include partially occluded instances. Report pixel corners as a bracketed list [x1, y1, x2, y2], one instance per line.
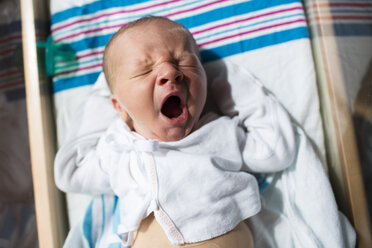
[212, 61, 296, 173]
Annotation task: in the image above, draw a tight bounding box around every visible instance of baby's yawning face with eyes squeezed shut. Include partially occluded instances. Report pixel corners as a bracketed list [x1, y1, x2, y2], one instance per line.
[109, 22, 207, 141]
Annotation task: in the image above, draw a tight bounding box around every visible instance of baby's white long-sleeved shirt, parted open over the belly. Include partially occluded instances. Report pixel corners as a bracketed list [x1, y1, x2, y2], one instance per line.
[55, 62, 295, 245]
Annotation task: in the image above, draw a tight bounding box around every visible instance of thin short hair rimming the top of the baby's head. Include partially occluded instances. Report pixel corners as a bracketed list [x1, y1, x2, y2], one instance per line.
[103, 16, 200, 92]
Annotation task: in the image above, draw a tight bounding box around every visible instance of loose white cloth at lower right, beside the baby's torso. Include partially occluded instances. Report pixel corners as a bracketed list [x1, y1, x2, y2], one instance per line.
[247, 127, 356, 248]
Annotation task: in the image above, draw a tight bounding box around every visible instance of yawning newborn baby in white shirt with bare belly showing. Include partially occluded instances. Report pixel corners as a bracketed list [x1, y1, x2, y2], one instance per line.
[55, 17, 295, 248]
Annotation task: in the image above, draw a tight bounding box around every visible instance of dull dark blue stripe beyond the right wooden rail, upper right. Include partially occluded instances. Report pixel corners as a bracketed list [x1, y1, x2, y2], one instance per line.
[333, 22, 372, 36]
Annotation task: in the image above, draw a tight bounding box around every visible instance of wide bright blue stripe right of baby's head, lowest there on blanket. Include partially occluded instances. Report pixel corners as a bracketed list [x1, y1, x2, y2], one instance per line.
[200, 27, 309, 63]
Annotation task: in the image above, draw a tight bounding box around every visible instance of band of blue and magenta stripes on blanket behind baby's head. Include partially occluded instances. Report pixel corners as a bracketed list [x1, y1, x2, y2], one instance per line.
[52, 0, 308, 92]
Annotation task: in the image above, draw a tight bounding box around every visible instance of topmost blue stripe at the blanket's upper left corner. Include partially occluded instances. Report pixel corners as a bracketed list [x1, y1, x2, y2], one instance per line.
[51, 0, 148, 25]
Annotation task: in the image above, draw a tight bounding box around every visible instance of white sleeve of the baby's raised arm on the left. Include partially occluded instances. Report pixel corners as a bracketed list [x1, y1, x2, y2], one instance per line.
[54, 74, 118, 194]
